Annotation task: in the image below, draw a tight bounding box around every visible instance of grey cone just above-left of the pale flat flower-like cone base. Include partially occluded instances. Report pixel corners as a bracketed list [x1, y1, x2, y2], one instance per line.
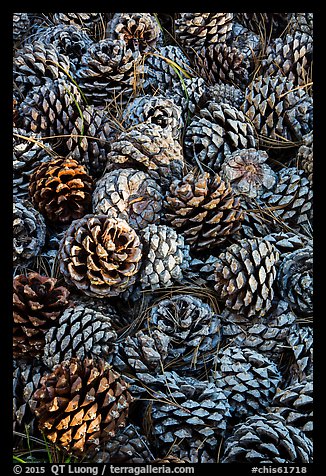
[184, 102, 256, 172]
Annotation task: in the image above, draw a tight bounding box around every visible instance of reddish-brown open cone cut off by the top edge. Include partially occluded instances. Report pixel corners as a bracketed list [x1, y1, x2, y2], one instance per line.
[106, 13, 162, 54]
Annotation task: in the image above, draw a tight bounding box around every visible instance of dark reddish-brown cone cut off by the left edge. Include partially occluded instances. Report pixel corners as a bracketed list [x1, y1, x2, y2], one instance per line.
[13, 272, 69, 359]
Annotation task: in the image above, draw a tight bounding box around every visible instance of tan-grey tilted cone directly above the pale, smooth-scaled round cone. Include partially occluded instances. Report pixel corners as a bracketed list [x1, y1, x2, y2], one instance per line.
[106, 123, 184, 189]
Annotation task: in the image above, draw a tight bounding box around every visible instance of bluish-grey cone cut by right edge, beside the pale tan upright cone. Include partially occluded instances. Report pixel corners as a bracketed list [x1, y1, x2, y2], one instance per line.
[277, 246, 313, 316]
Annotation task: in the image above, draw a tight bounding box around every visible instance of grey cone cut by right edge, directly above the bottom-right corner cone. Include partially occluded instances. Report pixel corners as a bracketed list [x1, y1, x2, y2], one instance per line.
[268, 378, 313, 439]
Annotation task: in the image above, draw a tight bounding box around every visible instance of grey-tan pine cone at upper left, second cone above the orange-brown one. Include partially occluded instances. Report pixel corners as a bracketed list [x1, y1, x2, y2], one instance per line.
[20, 78, 83, 136]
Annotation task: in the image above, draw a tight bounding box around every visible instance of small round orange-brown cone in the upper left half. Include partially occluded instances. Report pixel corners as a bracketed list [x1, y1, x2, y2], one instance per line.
[29, 157, 93, 223]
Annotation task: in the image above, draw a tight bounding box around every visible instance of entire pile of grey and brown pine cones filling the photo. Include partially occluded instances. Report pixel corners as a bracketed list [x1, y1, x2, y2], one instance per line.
[13, 13, 313, 464]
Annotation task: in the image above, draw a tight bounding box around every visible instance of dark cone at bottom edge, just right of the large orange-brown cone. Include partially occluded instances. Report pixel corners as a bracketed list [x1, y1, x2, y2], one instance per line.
[91, 423, 153, 465]
